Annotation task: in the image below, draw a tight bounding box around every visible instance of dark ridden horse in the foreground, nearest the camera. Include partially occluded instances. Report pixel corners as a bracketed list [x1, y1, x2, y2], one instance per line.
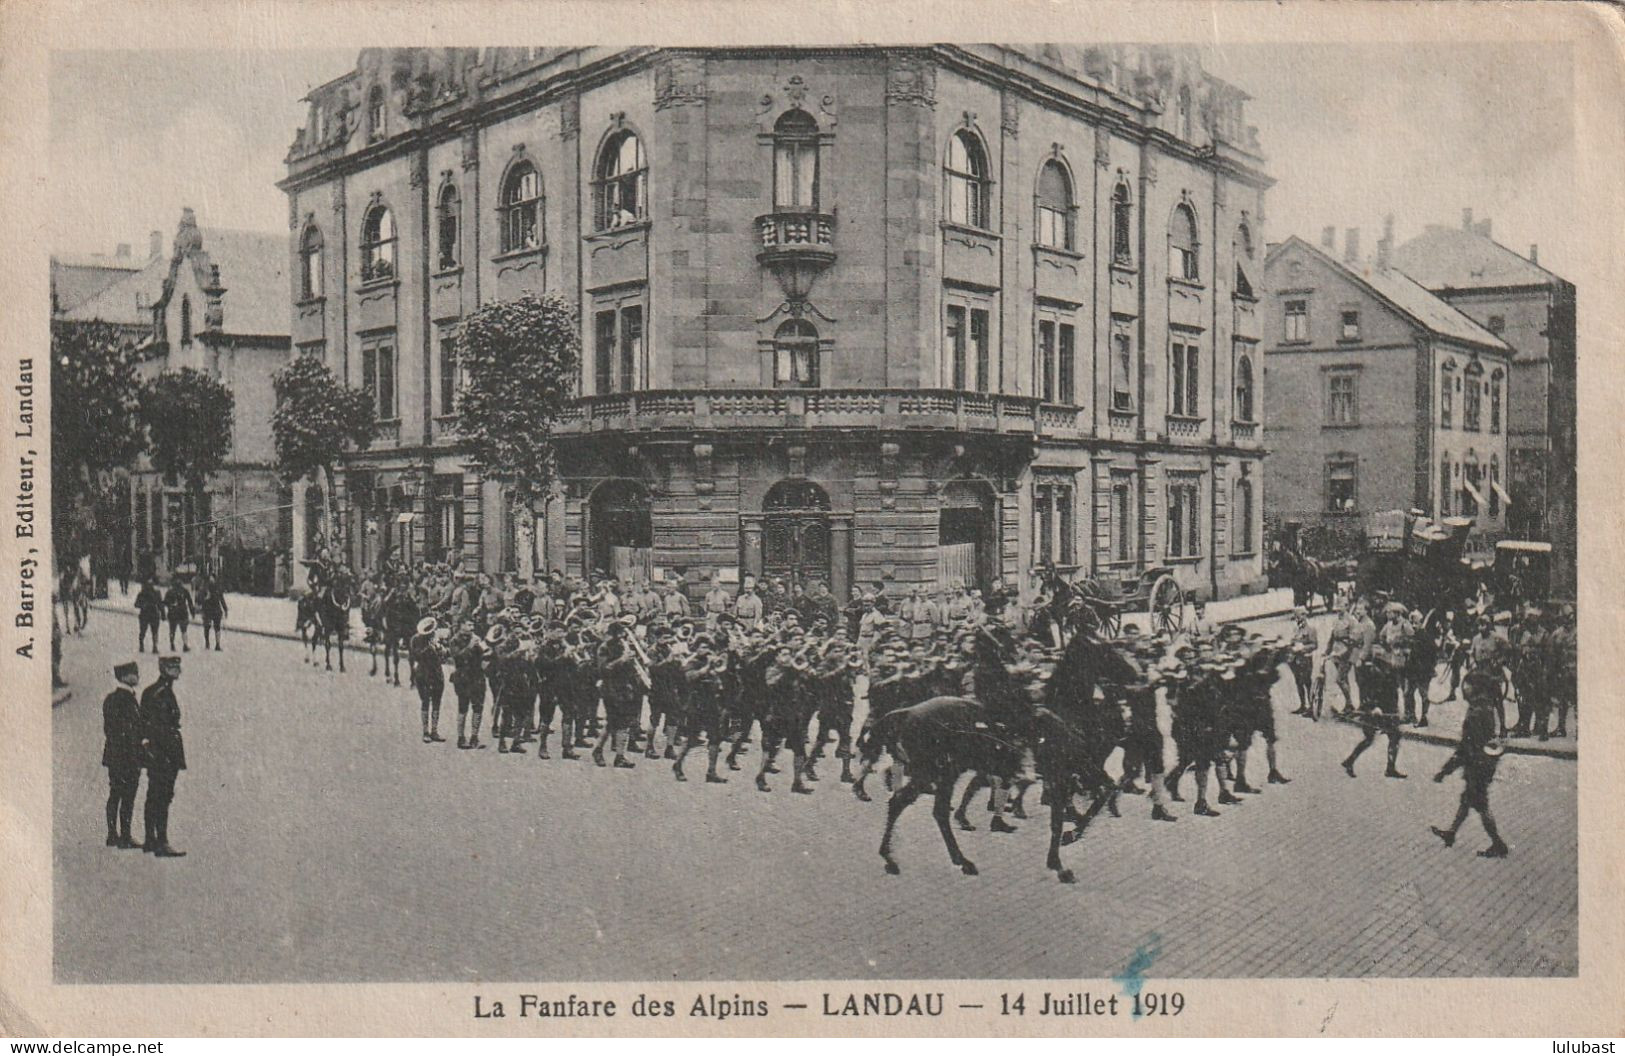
[863, 634, 1138, 884]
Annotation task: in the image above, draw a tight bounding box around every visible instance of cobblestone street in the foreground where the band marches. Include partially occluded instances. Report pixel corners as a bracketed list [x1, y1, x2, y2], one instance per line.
[52, 611, 1578, 983]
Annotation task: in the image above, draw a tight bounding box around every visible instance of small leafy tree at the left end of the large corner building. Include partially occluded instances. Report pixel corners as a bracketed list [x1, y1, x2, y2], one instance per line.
[271, 356, 377, 555]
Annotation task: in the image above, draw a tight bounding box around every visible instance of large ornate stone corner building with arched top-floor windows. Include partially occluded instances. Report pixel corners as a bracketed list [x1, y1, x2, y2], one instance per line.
[281, 45, 1271, 596]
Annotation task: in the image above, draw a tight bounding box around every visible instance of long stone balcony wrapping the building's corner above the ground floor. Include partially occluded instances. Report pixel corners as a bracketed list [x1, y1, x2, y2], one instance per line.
[554, 388, 1089, 437]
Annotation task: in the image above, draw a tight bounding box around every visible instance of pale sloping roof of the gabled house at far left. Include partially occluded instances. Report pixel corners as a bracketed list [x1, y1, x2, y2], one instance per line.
[62, 219, 289, 336]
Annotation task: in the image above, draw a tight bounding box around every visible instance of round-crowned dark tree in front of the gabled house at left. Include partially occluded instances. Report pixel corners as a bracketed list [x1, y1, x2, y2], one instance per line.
[141, 367, 236, 568]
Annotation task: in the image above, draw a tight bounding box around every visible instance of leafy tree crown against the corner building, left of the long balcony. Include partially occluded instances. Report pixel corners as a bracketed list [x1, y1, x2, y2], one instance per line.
[457, 294, 582, 512]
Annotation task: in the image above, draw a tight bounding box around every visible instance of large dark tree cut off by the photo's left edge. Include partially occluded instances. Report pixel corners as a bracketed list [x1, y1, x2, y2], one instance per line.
[50, 320, 146, 562]
